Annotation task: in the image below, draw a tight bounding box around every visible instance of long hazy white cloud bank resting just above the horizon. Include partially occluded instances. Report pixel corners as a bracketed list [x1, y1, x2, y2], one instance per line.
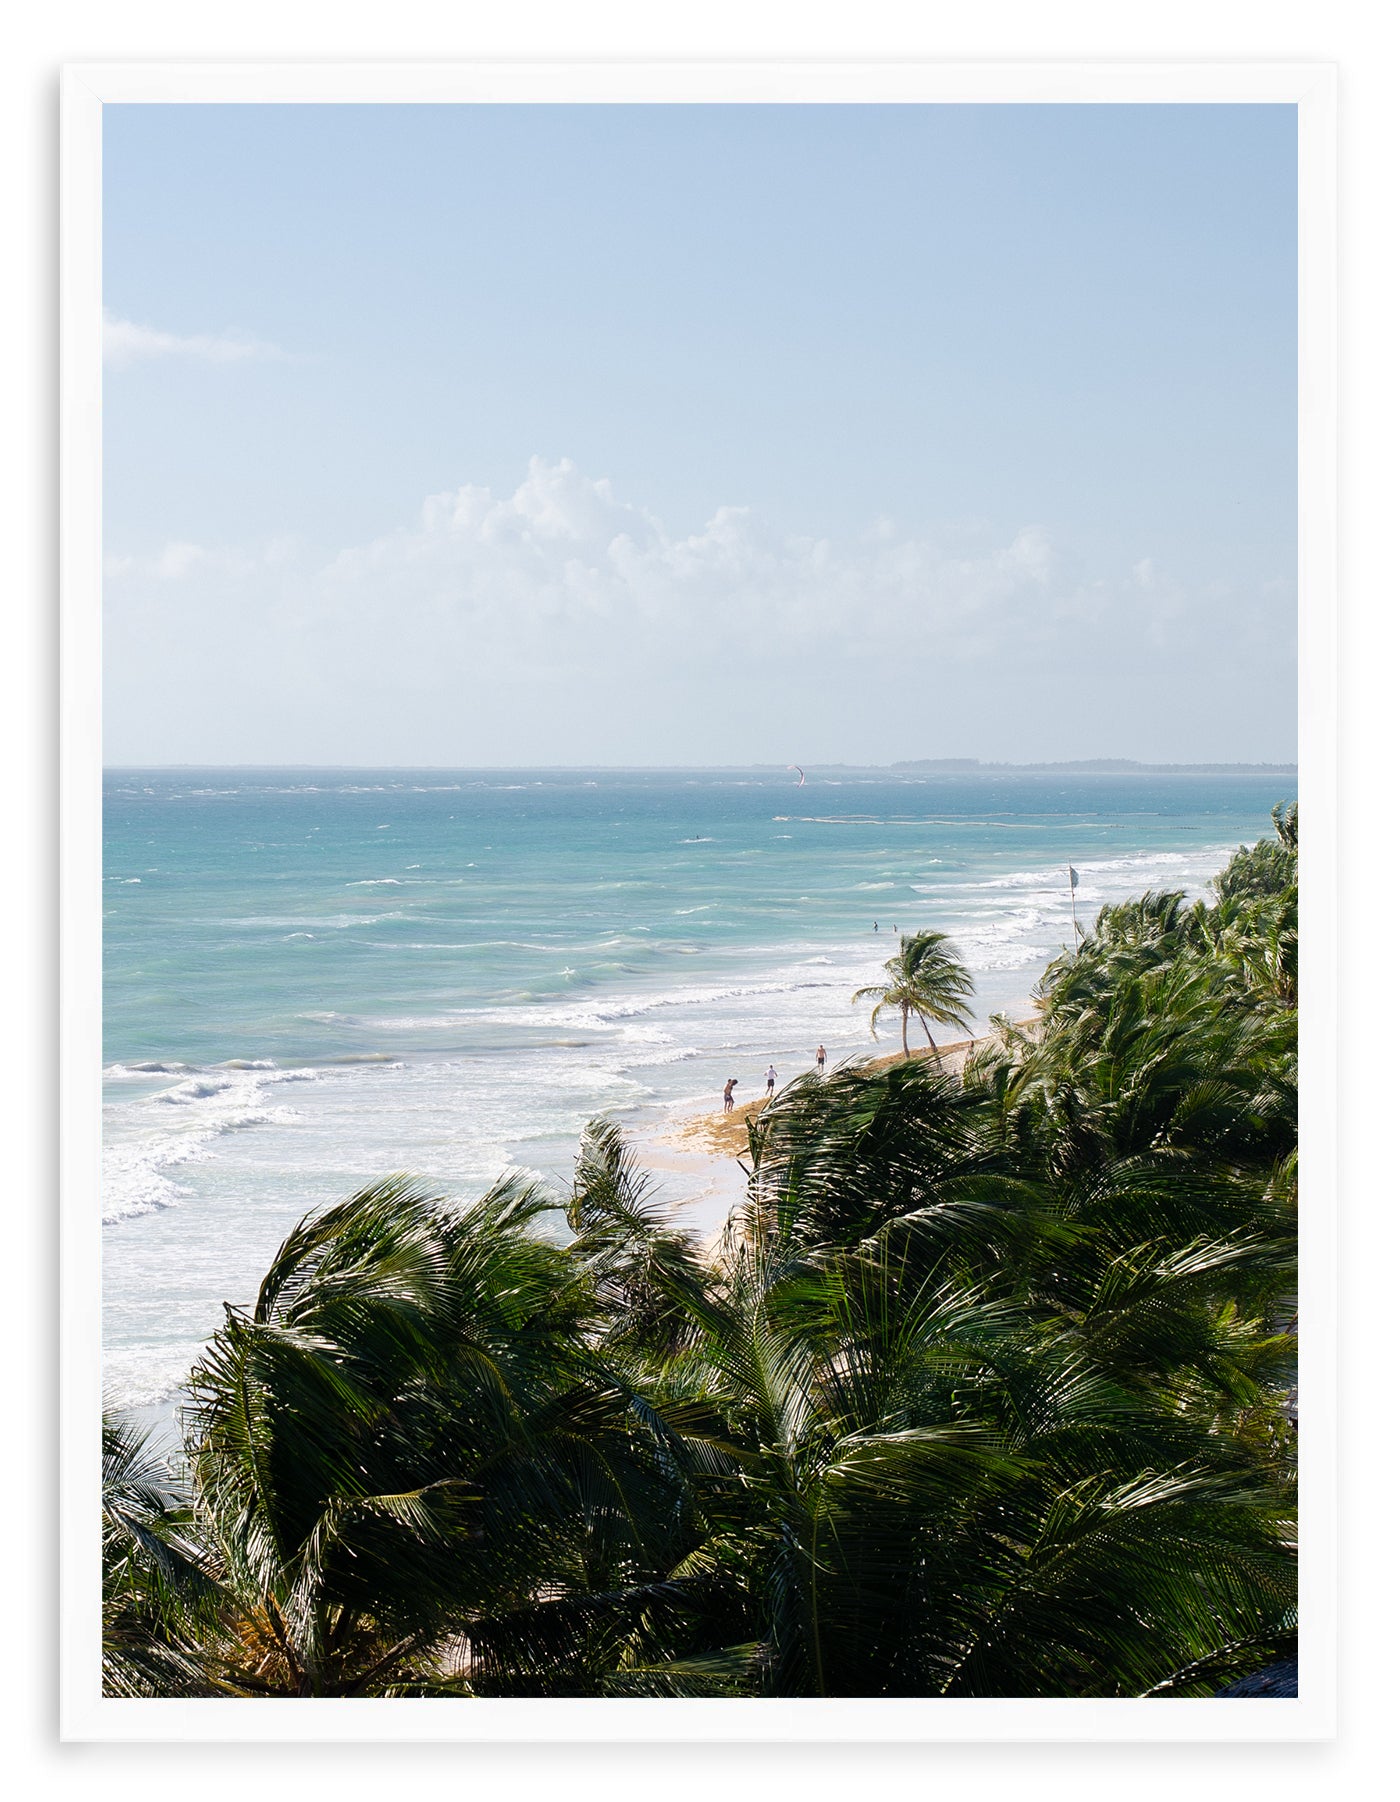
[108, 458, 1292, 764]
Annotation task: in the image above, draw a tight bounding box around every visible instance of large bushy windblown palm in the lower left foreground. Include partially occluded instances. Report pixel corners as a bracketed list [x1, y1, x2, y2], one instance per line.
[186, 1179, 699, 1696]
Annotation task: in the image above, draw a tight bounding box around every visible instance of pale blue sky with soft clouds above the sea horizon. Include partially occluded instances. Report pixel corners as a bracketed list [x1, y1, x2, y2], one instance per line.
[103, 105, 1297, 768]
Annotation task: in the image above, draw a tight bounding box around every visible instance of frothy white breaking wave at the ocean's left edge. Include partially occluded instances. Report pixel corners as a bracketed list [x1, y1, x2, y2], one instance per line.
[101, 1063, 323, 1225]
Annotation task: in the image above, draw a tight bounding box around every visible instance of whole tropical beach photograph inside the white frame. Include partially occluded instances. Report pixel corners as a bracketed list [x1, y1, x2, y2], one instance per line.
[84, 85, 1311, 1737]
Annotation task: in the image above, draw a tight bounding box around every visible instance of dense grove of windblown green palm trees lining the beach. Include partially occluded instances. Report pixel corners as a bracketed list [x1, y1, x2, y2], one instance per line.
[103, 815, 1297, 1697]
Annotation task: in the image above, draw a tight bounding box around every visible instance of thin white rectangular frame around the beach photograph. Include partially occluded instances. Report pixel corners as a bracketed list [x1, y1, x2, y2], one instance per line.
[59, 61, 1339, 1743]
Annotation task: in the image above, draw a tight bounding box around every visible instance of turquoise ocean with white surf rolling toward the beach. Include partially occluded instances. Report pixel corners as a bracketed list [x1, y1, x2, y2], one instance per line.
[101, 768, 1295, 1411]
